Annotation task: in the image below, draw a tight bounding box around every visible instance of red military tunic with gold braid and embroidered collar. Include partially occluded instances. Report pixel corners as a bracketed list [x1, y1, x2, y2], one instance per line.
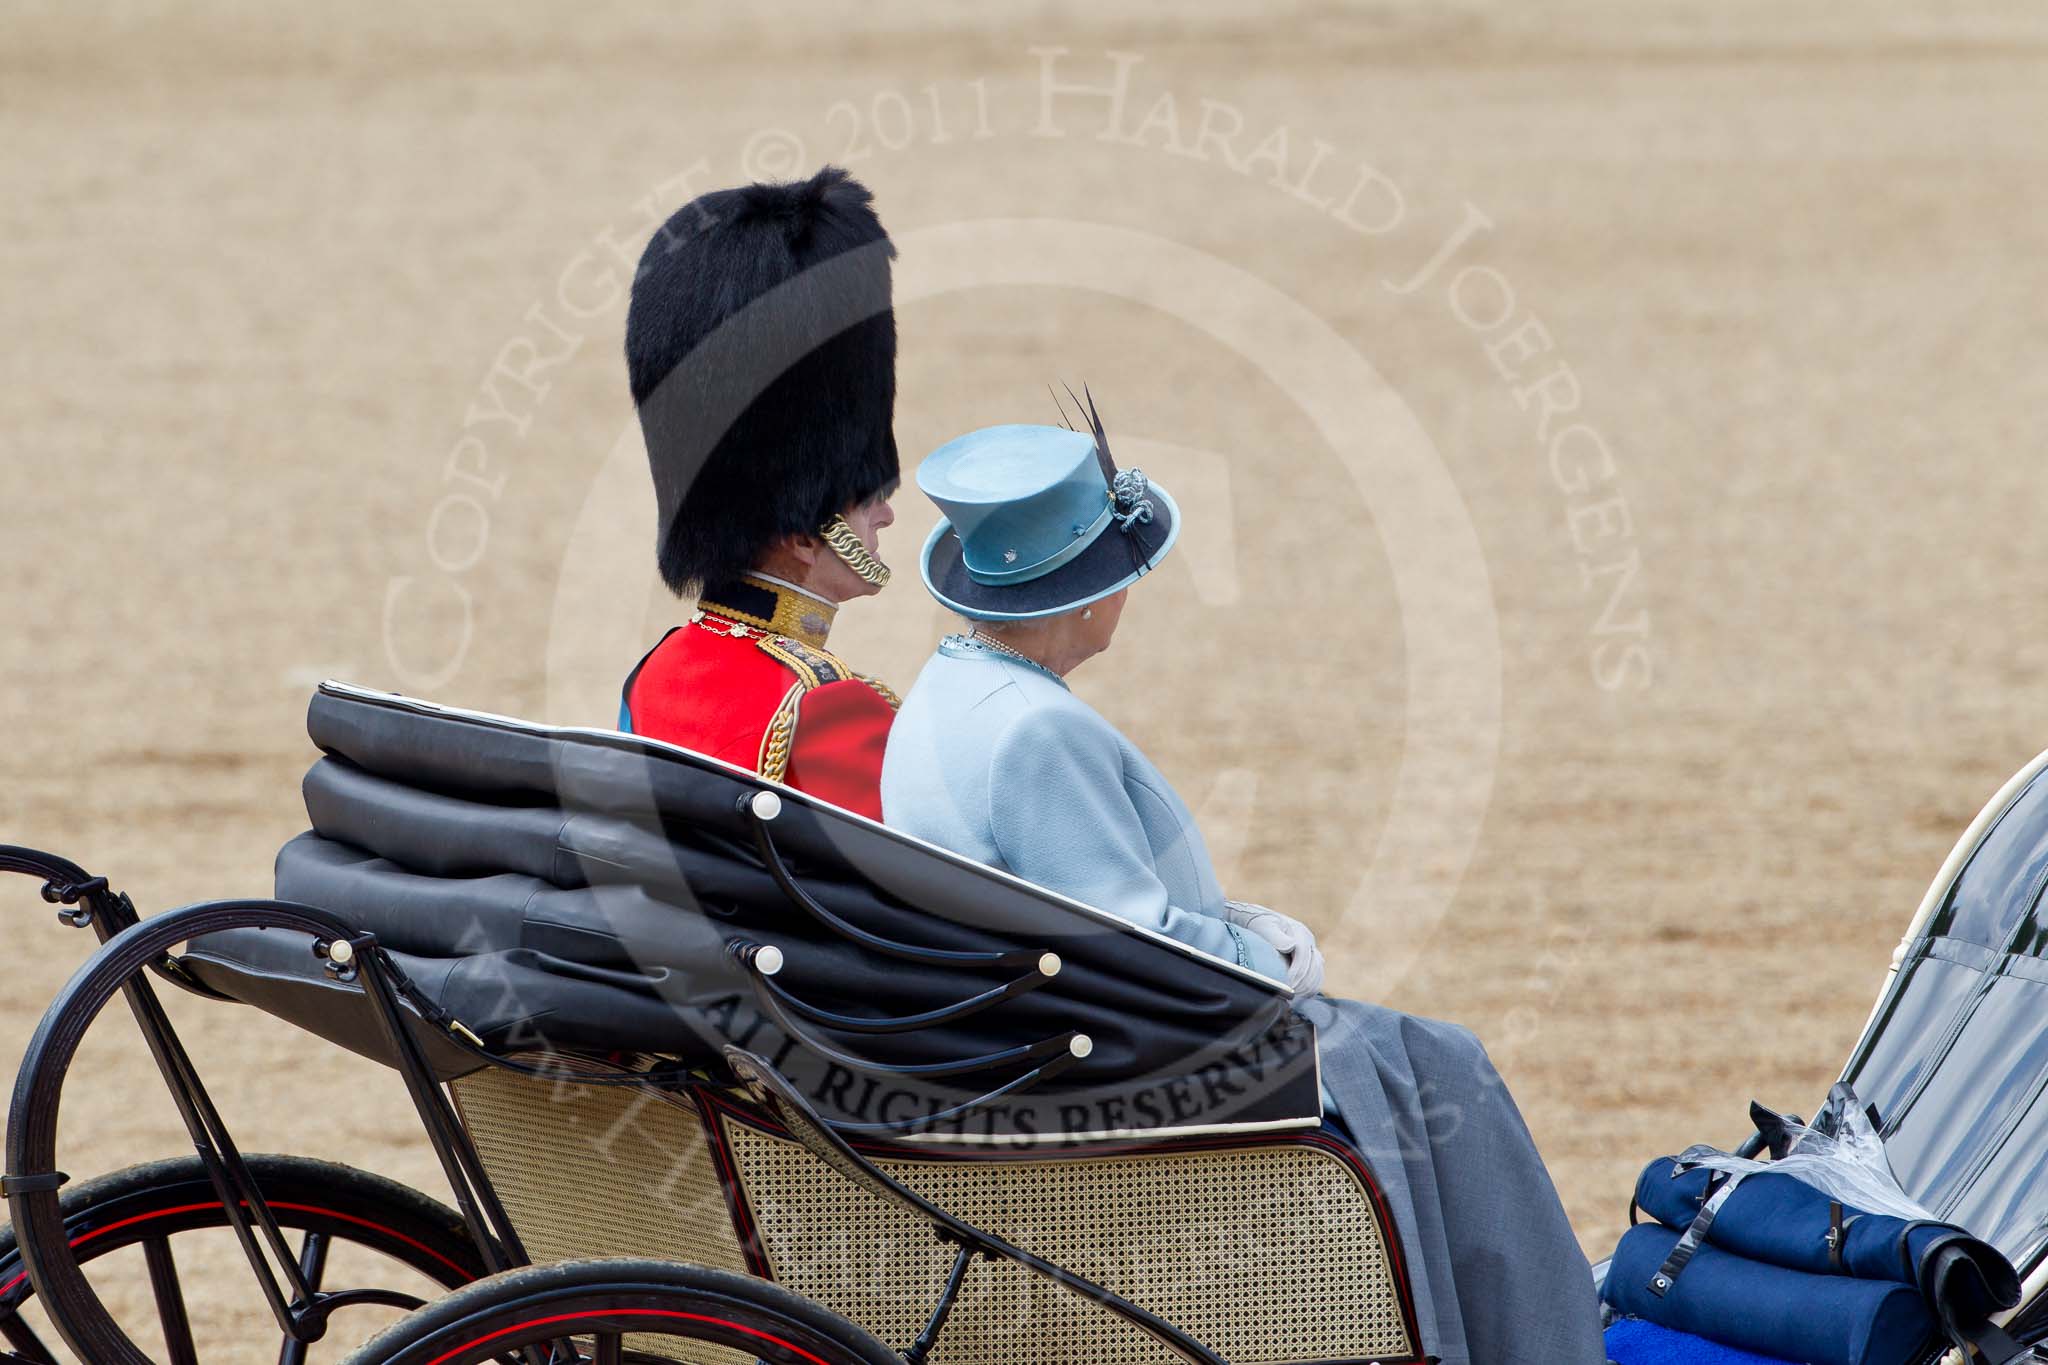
[618, 577, 897, 821]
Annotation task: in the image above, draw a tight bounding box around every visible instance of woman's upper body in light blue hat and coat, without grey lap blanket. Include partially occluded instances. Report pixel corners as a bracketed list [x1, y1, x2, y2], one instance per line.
[883, 426, 1321, 993]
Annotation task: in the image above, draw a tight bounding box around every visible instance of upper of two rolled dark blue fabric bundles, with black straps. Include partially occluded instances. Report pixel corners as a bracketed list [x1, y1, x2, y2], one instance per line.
[1636, 1156, 2019, 1322]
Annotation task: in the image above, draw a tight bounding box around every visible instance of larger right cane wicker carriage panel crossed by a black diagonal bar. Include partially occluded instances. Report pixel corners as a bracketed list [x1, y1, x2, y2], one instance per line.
[721, 1115, 1415, 1365]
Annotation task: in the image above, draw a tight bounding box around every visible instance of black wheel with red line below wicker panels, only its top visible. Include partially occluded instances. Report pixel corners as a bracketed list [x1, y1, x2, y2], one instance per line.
[348, 1261, 903, 1365]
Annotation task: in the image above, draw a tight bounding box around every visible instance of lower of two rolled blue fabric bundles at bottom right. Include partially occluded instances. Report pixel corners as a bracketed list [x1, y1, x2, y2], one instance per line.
[1602, 1220, 1935, 1365]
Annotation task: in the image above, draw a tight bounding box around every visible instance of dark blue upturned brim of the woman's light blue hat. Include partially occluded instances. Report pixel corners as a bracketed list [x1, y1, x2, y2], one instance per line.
[922, 483, 1180, 620]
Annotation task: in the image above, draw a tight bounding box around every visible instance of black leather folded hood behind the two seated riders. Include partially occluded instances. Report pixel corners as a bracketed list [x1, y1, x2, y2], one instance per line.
[188, 684, 1319, 1140]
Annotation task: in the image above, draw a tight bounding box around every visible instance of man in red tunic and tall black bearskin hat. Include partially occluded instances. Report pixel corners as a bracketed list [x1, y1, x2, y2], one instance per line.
[618, 168, 897, 819]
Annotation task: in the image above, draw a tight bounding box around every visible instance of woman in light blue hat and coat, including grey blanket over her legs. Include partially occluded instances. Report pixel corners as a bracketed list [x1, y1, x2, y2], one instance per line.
[883, 405, 1606, 1365]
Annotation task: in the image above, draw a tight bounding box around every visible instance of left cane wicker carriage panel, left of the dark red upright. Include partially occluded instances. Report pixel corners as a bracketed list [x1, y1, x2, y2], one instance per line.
[451, 1068, 754, 1365]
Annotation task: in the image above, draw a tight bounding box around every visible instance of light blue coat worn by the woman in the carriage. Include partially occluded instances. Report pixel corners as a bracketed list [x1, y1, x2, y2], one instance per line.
[883, 636, 1286, 980]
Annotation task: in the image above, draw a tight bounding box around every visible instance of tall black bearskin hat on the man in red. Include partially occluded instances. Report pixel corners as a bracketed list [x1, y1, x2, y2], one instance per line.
[627, 166, 897, 593]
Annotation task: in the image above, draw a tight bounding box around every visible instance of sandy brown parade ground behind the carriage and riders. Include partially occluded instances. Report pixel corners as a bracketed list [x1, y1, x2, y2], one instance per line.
[12, 0, 2048, 1361]
